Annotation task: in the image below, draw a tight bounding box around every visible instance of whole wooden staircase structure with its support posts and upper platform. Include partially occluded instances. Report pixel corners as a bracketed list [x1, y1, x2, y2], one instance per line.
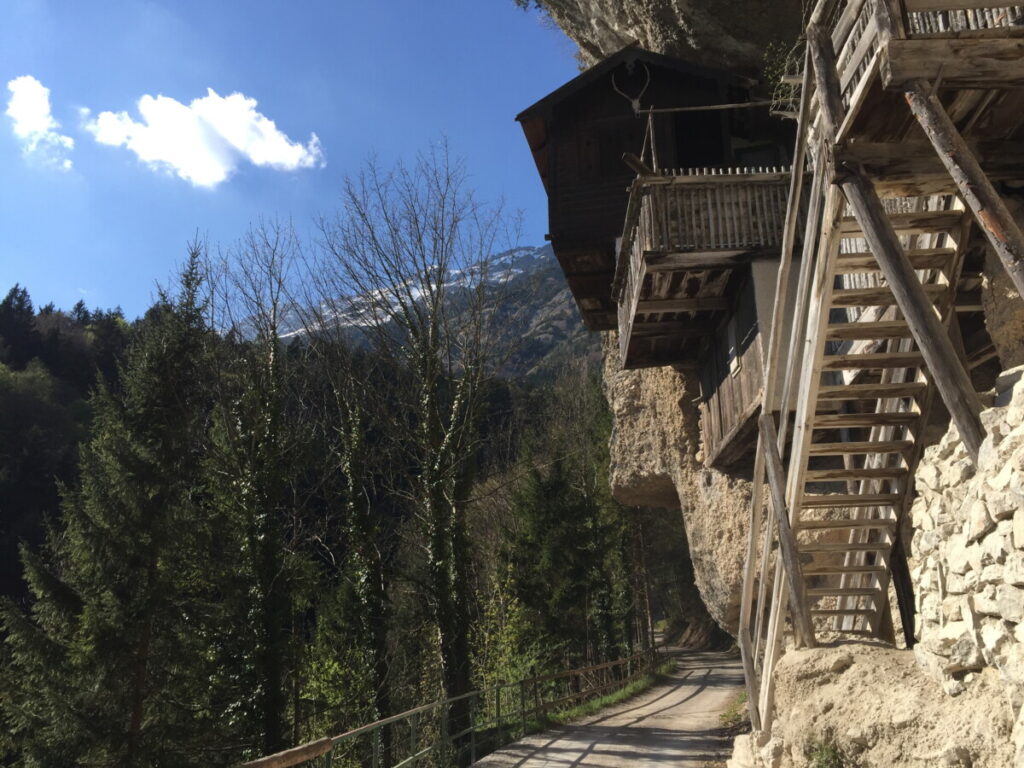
[737, 0, 1024, 732]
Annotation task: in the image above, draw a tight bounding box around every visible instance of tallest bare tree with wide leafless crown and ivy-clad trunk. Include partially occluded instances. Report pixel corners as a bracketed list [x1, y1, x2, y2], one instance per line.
[315, 144, 520, 741]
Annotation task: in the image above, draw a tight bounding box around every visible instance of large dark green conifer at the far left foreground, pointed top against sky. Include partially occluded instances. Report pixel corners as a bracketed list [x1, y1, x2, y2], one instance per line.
[0, 253, 230, 766]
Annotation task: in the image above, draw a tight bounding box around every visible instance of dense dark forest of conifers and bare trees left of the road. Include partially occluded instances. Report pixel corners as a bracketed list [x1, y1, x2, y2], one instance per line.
[0, 151, 712, 766]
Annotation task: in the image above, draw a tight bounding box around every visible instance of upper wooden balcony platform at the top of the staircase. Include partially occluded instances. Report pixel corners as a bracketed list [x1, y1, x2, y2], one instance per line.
[808, 0, 1024, 197]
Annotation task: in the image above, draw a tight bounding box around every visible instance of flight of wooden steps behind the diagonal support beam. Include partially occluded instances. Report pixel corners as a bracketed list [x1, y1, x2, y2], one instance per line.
[786, 196, 970, 641]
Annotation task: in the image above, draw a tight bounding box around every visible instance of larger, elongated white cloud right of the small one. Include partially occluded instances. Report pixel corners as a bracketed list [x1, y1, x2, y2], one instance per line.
[85, 88, 324, 187]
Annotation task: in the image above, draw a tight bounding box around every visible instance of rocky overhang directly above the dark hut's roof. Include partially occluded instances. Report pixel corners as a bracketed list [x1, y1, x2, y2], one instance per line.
[541, 0, 801, 74]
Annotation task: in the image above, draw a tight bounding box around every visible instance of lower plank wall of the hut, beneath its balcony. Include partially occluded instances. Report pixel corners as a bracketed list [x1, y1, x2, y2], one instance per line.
[700, 274, 764, 467]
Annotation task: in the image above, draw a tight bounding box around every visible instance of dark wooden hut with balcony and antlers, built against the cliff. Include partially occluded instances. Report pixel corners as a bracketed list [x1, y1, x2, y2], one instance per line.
[516, 46, 793, 465]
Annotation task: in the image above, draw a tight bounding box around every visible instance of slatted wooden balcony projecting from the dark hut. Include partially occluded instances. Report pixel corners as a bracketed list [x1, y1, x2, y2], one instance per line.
[612, 168, 790, 369]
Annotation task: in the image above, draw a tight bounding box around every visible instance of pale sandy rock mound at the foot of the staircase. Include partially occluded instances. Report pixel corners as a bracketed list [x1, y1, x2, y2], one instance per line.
[730, 643, 1021, 768]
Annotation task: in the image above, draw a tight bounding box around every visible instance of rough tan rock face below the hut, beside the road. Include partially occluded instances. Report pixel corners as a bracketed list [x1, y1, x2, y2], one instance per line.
[604, 334, 751, 634]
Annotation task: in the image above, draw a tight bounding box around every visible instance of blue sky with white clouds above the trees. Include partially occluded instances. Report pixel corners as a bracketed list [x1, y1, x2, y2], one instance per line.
[0, 0, 577, 317]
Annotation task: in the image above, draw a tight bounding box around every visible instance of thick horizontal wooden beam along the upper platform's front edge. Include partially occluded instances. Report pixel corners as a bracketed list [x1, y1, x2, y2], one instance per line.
[881, 37, 1024, 90]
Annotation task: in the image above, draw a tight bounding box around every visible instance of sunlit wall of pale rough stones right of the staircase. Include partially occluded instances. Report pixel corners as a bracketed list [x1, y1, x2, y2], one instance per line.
[909, 367, 1024, 746]
